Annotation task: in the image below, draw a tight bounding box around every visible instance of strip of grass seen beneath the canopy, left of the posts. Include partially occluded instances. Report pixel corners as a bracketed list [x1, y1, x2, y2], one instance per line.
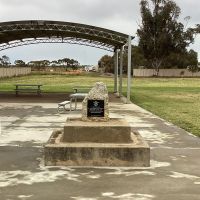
[0, 74, 113, 92]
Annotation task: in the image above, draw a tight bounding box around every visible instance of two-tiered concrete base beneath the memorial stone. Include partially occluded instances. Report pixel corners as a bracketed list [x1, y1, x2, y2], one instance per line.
[44, 118, 150, 167]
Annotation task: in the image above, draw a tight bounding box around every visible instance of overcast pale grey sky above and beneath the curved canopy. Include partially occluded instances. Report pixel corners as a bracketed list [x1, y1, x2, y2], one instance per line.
[0, 0, 200, 65]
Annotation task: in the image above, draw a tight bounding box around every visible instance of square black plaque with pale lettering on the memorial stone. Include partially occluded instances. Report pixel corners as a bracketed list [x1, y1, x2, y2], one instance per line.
[87, 100, 104, 117]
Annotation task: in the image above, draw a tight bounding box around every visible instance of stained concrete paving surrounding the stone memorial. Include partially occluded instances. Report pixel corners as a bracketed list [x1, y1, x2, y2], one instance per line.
[0, 96, 200, 200]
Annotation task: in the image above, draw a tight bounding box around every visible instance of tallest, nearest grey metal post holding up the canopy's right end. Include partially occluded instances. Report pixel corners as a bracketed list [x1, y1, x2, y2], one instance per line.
[127, 36, 131, 103]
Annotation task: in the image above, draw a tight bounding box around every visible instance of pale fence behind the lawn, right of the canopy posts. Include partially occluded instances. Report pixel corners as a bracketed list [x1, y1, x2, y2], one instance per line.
[133, 69, 200, 77]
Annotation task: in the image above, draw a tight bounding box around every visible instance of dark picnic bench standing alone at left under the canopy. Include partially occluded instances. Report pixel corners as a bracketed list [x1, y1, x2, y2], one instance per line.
[15, 84, 42, 96]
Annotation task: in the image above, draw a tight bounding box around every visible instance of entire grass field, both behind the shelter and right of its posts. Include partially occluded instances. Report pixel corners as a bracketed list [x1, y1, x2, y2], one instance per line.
[0, 75, 200, 136]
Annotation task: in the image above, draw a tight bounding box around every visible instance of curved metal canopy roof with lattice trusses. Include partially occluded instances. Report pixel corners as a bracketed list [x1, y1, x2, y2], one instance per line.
[0, 20, 134, 51]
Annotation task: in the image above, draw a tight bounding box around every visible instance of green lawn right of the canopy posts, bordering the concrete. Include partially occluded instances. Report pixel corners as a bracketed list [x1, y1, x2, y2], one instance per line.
[131, 78, 200, 136]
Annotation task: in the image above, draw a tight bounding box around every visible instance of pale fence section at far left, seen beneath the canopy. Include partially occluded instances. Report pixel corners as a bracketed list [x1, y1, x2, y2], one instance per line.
[0, 67, 31, 78]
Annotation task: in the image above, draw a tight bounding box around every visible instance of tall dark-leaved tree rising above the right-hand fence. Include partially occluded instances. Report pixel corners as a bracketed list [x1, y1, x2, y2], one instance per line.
[137, 0, 193, 75]
